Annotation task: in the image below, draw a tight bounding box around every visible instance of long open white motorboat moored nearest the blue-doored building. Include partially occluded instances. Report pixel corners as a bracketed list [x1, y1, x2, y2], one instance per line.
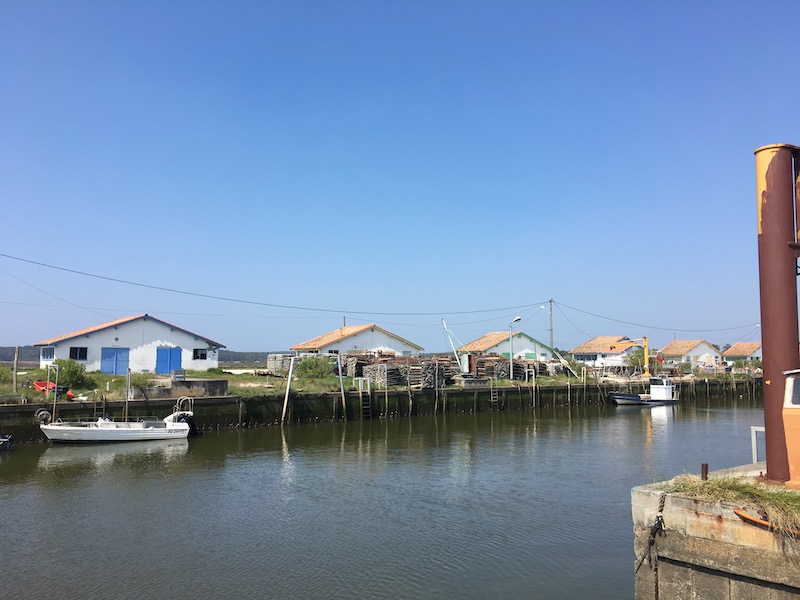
[37, 398, 196, 442]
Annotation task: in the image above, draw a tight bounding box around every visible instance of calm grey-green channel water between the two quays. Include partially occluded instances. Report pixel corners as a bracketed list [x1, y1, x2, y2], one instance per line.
[0, 400, 763, 600]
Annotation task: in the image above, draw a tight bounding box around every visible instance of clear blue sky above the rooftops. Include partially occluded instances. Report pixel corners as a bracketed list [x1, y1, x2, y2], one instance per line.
[0, 0, 788, 351]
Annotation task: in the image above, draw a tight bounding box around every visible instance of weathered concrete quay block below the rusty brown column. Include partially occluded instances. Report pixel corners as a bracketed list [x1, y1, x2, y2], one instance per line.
[631, 463, 800, 600]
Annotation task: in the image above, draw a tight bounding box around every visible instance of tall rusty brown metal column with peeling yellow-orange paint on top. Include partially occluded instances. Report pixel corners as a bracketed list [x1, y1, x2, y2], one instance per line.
[755, 144, 800, 481]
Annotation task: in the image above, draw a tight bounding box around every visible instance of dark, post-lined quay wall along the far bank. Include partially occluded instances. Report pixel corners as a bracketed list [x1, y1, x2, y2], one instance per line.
[0, 379, 761, 442]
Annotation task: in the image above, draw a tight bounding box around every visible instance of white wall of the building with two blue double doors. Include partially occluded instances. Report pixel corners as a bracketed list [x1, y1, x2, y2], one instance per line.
[40, 319, 219, 373]
